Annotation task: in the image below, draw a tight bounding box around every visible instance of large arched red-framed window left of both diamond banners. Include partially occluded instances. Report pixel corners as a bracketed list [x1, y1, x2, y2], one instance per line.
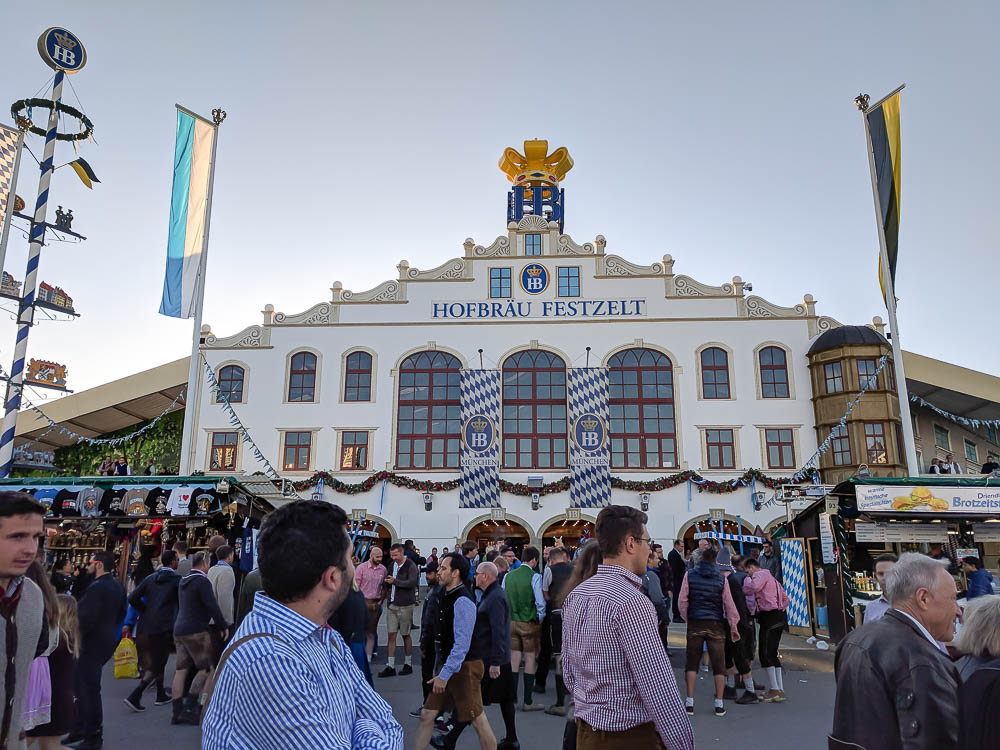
[396, 352, 462, 469]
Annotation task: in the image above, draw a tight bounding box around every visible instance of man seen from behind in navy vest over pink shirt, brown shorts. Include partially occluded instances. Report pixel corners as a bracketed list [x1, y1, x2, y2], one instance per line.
[677, 547, 740, 716]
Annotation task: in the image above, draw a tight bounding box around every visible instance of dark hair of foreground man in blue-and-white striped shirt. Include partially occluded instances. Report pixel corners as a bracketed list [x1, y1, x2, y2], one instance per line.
[257, 500, 351, 603]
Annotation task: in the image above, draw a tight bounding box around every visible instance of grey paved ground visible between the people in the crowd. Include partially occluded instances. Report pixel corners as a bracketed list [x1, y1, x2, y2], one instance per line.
[103, 626, 834, 750]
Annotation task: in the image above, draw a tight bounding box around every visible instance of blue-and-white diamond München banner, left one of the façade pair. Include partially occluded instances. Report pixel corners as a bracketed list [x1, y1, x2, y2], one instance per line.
[458, 370, 500, 508]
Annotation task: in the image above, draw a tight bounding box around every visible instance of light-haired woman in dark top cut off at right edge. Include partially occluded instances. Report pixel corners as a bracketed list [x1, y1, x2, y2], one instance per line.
[955, 595, 1000, 750]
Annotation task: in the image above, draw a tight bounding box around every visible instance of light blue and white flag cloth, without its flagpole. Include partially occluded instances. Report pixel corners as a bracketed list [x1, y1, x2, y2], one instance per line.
[160, 107, 217, 318]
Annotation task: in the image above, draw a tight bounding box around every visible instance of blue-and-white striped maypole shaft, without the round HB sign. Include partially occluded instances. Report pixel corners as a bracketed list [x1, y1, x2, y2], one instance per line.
[0, 70, 66, 478]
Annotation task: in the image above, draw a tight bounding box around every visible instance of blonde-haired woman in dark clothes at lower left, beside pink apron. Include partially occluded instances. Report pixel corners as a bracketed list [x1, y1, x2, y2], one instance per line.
[28, 594, 80, 750]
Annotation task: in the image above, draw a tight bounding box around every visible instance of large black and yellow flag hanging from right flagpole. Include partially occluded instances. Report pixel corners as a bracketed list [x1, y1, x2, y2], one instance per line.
[865, 91, 902, 304]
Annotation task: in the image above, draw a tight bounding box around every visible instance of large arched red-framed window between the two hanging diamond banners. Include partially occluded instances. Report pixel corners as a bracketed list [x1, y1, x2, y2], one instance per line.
[503, 349, 567, 469]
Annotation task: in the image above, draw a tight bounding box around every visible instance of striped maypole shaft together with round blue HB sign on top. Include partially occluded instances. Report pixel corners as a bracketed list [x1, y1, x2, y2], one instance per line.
[0, 28, 87, 477]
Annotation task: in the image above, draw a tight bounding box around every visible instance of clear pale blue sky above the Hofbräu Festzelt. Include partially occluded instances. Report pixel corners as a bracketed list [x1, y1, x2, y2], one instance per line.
[0, 0, 1000, 400]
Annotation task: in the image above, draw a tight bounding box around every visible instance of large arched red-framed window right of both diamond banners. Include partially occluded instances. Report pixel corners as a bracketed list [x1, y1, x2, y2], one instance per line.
[608, 349, 677, 469]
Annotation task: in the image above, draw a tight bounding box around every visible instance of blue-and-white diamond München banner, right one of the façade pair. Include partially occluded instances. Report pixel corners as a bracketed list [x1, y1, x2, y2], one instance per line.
[568, 367, 611, 508]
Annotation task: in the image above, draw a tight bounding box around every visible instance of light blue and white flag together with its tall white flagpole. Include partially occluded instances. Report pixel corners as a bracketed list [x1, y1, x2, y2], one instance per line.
[160, 105, 226, 475]
